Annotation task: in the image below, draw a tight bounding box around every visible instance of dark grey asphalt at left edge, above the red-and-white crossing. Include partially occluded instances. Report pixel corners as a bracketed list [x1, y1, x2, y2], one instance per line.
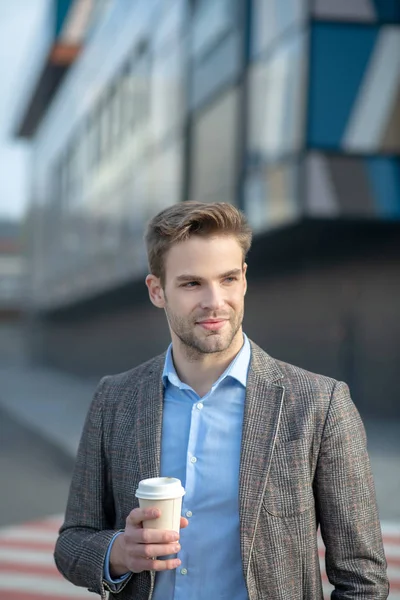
[0, 409, 73, 527]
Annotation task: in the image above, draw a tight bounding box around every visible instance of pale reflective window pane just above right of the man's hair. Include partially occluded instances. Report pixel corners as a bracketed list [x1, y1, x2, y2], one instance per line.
[244, 164, 300, 233]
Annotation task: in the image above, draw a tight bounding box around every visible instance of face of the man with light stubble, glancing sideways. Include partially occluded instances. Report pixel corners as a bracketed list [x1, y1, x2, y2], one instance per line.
[153, 235, 247, 354]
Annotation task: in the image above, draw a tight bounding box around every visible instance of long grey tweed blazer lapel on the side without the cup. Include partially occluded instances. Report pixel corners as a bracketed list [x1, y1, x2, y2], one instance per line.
[239, 343, 284, 574]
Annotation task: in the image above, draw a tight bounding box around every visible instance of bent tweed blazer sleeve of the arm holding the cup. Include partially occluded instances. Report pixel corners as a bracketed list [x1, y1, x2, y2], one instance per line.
[54, 377, 130, 598]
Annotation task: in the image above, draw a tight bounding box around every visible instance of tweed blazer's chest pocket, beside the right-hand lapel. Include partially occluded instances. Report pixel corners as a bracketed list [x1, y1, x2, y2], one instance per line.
[263, 438, 314, 517]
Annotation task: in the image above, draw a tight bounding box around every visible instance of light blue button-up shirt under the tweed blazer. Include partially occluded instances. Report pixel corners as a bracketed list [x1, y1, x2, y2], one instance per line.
[105, 336, 251, 600]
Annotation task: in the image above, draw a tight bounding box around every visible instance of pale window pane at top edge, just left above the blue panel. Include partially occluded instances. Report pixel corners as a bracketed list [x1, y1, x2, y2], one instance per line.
[251, 0, 308, 56]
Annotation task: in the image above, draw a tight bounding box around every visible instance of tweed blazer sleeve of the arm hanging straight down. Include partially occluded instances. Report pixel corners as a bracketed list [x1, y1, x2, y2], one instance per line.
[315, 382, 389, 600]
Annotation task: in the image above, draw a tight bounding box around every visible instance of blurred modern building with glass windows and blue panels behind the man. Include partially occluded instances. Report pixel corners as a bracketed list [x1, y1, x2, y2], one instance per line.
[19, 0, 400, 414]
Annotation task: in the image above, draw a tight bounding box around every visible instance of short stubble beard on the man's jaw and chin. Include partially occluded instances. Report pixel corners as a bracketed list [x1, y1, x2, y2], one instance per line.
[165, 307, 243, 360]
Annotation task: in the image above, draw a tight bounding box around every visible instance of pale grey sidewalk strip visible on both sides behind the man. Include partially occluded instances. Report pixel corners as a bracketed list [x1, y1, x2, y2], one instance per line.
[0, 366, 400, 523]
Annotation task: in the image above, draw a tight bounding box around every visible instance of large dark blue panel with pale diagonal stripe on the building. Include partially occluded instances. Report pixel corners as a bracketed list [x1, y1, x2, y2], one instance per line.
[308, 23, 400, 154]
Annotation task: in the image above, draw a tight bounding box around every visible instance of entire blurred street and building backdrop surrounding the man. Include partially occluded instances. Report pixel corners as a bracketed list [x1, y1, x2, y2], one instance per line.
[0, 0, 400, 600]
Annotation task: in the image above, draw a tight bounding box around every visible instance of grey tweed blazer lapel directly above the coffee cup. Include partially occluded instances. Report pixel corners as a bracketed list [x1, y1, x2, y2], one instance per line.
[135, 354, 165, 479]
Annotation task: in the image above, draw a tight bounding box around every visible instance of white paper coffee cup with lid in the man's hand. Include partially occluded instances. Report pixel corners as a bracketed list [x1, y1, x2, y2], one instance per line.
[135, 477, 185, 532]
